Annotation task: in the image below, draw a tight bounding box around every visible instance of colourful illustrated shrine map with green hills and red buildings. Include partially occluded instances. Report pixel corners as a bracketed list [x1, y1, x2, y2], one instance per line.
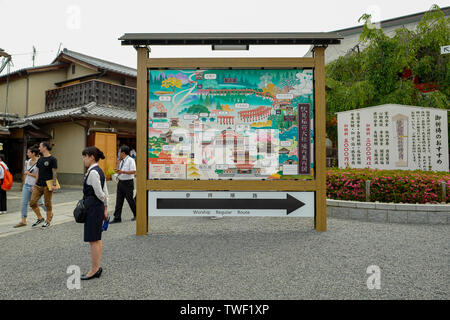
[148, 69, 314, 180]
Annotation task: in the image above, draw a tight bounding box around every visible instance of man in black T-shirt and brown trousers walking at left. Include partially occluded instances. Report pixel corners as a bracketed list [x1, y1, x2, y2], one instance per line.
[30, 141, 58, 228]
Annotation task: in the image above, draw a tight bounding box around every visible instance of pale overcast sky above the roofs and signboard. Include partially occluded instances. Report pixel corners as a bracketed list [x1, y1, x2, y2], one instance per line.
[0, 0, 448, 73]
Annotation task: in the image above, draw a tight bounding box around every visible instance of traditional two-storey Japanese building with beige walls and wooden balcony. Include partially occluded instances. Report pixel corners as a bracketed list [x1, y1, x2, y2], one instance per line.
[0, 49, 137, 184]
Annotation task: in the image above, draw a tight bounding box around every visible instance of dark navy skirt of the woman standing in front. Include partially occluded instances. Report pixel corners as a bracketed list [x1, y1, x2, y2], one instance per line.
[84, 198, 105, 242]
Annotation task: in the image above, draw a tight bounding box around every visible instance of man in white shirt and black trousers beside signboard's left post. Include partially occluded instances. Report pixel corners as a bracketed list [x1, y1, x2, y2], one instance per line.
[111, 146, 136, 223]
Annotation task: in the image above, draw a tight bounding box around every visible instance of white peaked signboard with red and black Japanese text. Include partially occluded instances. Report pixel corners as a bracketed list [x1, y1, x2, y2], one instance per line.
[337, 104, 449, 171]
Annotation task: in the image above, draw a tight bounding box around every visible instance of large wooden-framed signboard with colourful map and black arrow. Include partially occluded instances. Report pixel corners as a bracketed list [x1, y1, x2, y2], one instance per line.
[137, 47, 326, 235]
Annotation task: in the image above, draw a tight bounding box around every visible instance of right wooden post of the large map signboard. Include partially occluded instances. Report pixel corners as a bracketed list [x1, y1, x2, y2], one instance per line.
[314, 47, 327, 231]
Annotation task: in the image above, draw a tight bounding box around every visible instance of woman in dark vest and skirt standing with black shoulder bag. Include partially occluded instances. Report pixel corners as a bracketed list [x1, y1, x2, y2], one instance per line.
[81, 147, 109, 280]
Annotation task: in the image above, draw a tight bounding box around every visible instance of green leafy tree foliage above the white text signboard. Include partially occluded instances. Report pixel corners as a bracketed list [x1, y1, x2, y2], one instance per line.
[326, 5, 450, 142]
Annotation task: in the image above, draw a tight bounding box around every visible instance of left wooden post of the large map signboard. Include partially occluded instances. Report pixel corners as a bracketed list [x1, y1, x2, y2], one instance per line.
[136, 47, 149, 236]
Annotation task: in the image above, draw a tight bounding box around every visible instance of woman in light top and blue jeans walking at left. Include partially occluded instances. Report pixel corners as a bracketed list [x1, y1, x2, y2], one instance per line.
[14, 146, 47, 228]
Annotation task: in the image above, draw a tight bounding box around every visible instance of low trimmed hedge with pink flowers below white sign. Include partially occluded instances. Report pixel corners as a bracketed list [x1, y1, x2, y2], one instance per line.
[327, 168, 450, 203]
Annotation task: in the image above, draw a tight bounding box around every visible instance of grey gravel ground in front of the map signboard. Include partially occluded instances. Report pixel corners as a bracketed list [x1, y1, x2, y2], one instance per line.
[0, 185, 450, 300]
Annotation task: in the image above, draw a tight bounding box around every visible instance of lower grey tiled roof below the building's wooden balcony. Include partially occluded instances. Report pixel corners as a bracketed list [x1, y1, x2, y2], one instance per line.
[21, 102, 136, 122]
